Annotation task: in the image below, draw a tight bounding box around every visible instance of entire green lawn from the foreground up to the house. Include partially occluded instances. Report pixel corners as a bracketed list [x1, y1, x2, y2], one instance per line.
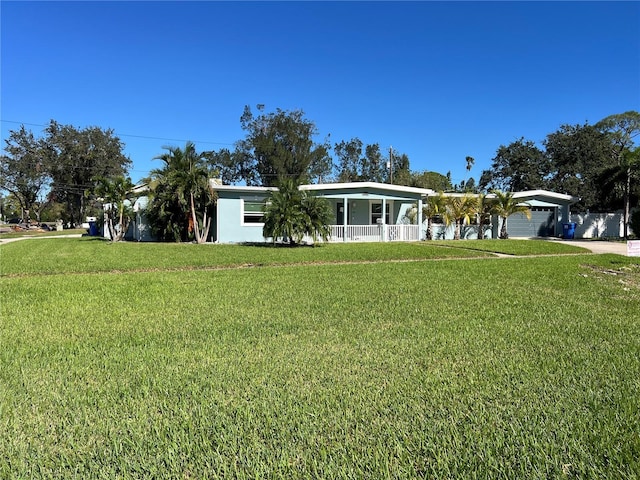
[0, 239, 640, 479]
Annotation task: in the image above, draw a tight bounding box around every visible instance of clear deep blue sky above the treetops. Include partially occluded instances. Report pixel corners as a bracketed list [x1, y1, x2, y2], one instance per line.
[0, 0, 640, 183]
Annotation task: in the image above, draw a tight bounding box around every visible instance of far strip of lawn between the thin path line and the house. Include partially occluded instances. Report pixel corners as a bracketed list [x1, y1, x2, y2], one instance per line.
[0, 237, 586, 276]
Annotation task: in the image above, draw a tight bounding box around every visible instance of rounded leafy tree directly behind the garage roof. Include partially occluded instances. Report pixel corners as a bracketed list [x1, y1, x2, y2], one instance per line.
[479, 138, 551, 191]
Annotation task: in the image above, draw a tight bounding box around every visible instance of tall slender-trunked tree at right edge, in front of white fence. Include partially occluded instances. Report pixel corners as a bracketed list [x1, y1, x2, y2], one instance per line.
[596, 111, 640, 238]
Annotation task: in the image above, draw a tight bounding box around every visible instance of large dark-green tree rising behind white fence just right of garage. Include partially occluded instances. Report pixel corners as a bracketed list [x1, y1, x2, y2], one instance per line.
[544, 123, 612, 211]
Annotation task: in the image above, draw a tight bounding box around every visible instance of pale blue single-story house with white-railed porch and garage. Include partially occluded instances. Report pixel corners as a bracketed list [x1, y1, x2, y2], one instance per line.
[111, 179, 578, 243]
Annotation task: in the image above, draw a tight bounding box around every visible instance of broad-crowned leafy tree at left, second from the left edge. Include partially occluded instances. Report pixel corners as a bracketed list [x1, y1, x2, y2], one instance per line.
[42, 120, 131, 225]
